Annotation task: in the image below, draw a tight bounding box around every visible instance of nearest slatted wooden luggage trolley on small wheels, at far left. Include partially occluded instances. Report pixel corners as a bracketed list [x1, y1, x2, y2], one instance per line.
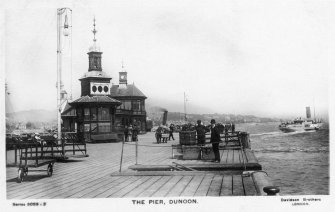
[17, 143, 57, 183]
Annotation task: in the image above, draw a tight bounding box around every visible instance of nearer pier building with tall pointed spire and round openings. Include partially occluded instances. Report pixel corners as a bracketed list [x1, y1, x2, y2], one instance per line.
[62, 20, 121, 141]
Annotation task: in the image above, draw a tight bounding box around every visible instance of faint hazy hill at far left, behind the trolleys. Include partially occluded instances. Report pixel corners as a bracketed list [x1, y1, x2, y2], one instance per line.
[6, 110, 57, 123]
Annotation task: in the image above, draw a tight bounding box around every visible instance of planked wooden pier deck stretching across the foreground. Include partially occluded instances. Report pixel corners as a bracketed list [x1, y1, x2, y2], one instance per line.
[6, 133, 274, 199]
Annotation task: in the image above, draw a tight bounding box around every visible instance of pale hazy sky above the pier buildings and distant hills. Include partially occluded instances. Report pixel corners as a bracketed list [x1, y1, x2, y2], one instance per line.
[5, 0, 334, 117]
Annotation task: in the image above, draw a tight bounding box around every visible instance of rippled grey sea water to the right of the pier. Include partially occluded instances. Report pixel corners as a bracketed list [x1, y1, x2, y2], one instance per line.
[236, 123, 329, 195]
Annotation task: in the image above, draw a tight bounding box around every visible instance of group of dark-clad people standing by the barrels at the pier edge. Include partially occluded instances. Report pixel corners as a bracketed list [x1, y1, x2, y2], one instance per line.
[195, 119, 235, 163]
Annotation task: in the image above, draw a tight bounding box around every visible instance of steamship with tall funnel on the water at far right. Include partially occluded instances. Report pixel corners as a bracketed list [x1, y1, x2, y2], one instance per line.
[279, 107, 322, 132]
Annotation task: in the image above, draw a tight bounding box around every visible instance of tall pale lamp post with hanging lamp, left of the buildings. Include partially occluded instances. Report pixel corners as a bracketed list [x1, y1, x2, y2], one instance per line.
[57, 8, 72, 144]
